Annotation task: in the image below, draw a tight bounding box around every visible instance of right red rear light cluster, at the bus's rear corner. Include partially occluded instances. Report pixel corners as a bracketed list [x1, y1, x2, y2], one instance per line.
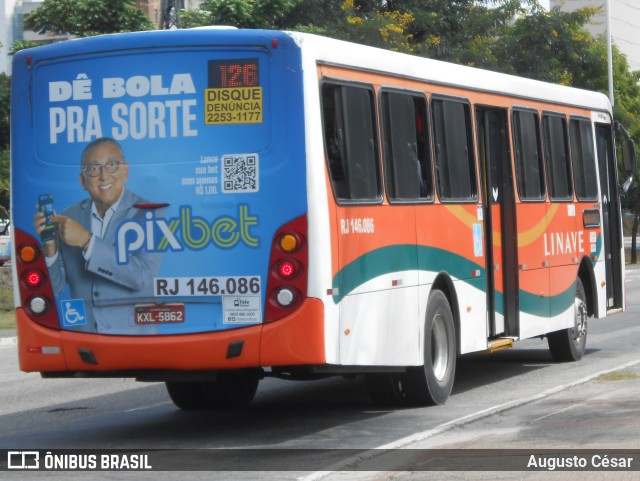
[265, 216, 308, 322]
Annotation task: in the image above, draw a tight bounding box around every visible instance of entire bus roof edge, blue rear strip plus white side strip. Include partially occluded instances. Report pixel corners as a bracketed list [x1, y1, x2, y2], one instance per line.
[14, 28, 611, 112]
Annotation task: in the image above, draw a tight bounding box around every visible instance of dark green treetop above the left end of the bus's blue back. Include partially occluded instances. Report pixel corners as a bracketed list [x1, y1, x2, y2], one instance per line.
[25, 0, 154, 37]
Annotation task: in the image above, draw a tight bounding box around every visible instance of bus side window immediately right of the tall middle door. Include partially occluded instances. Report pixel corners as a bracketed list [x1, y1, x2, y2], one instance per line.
[513, 110, 545, 200]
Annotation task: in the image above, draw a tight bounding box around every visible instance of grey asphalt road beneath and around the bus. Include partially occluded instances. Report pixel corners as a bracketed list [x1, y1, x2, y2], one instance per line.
[0, 264, 640, 481]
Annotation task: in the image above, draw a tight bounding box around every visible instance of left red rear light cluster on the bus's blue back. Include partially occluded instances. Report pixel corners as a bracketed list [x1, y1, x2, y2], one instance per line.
[15, 229, 60, 329]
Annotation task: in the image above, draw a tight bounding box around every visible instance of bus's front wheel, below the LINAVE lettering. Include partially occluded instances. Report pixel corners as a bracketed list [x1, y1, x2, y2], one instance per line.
[547, 279, 589, 362]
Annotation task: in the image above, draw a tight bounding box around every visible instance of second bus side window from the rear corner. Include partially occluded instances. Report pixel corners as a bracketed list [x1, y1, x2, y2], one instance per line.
[381, 91, 433, 202]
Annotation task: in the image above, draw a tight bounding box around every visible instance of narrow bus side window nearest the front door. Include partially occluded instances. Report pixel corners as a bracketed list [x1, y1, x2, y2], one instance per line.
[569, 119, 598, 201]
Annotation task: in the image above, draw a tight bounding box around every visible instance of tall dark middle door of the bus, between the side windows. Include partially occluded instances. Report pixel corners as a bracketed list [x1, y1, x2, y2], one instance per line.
[476, 107, 518, 337]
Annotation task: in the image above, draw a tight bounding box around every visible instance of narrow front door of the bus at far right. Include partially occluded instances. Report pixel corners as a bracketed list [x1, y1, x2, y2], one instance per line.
[596, 124, 624, 309]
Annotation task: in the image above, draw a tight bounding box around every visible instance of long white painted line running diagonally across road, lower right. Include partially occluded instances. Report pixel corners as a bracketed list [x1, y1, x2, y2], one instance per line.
[298, 359, 640, 481]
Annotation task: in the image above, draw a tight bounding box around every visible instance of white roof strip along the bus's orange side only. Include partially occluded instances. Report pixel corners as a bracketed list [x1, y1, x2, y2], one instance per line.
[290, 32, 611, 112]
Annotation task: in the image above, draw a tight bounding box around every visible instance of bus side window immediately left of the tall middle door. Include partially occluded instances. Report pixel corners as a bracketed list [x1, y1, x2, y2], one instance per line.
[431, 98, 478, 201]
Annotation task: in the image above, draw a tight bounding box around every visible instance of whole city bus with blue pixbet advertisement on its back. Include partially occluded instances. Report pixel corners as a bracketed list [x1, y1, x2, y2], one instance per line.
[11, 28, 635, 409]
